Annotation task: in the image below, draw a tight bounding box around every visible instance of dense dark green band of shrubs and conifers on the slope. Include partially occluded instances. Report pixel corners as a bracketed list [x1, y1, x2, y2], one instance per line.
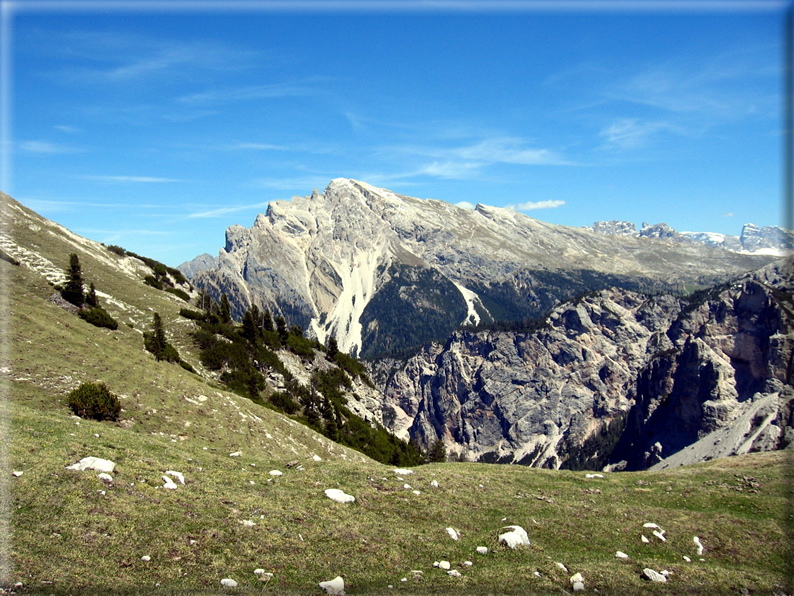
[180, 293, 438, 466]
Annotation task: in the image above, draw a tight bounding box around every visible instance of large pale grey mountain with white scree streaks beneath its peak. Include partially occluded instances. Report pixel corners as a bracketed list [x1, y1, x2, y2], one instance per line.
[180, 179, 771, 356]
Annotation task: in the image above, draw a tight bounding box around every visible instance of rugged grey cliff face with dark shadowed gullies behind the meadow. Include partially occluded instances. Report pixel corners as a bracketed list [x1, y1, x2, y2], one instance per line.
[376, 261, 794, 469]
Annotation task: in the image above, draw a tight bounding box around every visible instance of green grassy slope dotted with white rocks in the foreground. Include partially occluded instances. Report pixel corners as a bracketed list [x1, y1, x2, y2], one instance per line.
[0, 196, 794, 595]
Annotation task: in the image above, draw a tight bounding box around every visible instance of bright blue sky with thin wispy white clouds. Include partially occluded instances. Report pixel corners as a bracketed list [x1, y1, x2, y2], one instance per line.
[2, 2, 786, 265]
